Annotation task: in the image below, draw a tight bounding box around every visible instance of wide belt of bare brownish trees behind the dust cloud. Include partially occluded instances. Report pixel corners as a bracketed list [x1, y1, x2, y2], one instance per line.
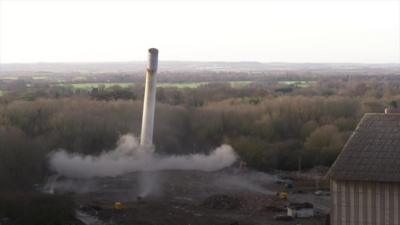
[0, 76, 400, 192]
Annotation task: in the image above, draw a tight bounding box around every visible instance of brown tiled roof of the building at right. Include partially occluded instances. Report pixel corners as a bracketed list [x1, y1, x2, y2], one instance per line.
[328, 113, 400, 182]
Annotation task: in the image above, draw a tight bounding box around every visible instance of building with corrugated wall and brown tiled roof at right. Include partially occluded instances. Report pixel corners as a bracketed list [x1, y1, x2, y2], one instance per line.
[328, 113, 400, 225]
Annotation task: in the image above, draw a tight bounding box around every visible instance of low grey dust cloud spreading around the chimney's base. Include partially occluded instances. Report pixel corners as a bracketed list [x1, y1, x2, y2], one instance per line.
[49, 134, 237, 178]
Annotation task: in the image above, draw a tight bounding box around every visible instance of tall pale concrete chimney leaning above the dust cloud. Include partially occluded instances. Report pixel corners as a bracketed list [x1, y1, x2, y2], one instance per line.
[140, 48, 158, 147]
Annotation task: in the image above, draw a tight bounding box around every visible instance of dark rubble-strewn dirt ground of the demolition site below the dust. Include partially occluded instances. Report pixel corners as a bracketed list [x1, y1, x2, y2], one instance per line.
[50, 169, 329, 225]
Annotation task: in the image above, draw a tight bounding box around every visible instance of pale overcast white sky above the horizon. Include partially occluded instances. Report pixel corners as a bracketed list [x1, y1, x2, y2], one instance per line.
[0, 0, 400, 63]
